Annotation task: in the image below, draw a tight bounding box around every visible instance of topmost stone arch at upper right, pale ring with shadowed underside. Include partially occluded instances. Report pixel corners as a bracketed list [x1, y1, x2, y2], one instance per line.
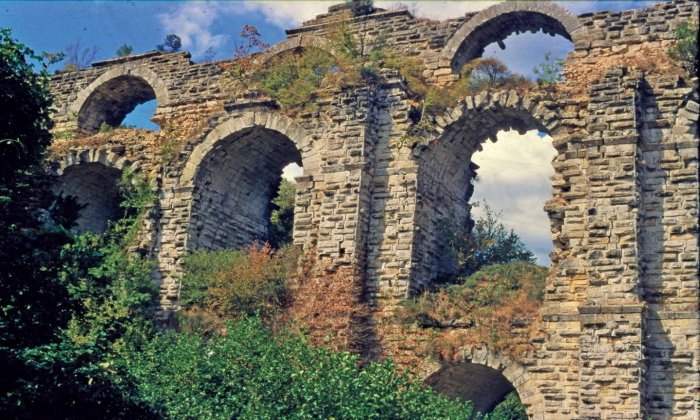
[439, 1, 588, 72]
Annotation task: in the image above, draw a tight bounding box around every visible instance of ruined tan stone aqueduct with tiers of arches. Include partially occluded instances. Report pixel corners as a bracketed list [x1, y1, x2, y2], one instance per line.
[46, 1, 700, 419]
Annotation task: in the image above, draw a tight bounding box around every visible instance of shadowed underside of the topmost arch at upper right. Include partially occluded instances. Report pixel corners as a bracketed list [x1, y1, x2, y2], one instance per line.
[452, 11, 571, 72]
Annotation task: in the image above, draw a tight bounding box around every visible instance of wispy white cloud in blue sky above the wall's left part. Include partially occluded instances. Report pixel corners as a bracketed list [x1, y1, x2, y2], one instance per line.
[158, 2, 231, 56]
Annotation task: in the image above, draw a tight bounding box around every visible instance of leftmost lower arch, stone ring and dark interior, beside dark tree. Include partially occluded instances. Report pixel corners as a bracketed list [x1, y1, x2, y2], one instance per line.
[50, 148, 139, 234]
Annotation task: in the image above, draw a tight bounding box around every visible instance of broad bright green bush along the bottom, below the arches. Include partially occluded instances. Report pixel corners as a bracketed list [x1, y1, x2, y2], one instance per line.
[126, 319, 472, 419]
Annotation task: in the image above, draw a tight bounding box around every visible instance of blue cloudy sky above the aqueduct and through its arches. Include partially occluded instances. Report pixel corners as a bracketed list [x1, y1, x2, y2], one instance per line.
[0, 1, 655, 264]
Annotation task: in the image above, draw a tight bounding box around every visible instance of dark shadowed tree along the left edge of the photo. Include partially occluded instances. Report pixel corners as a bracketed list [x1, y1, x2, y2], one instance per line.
[0, 29, 69, 354]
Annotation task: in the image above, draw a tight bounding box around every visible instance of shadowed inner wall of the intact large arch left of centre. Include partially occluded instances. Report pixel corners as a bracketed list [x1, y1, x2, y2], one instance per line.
[189, 127, 301, 249]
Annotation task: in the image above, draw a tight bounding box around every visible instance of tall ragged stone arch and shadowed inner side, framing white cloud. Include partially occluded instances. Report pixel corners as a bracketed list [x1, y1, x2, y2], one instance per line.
[410, 90, 565, 293]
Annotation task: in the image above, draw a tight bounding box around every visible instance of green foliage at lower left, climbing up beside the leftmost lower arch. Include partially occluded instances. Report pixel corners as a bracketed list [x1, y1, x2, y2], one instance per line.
[0, 170, 156, 418]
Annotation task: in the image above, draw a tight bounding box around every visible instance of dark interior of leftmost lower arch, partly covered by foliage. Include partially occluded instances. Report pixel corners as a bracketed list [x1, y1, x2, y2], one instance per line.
[53, 163, 122, 234]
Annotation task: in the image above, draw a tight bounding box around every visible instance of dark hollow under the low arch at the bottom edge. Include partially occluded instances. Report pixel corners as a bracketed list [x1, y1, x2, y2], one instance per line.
[424, 363, 515, 413]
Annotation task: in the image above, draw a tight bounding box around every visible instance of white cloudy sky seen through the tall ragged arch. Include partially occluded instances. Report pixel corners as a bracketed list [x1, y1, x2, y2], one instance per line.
[472, 130, 556, 264]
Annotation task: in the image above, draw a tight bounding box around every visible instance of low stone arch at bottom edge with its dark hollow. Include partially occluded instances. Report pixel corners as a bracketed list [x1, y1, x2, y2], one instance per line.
[423, 346, 544, 419]
